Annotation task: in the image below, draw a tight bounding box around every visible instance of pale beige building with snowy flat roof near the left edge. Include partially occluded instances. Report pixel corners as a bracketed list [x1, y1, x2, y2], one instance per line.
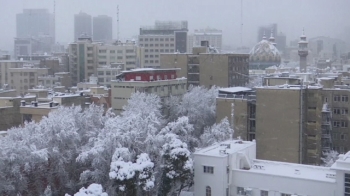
[8, 64, 48, 95]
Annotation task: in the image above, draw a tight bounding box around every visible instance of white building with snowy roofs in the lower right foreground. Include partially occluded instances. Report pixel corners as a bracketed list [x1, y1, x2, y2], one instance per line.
[194, 140, 350, 196]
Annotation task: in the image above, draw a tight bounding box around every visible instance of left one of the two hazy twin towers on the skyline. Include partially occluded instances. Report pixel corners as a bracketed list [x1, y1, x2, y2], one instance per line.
[74, 12, 92, 41]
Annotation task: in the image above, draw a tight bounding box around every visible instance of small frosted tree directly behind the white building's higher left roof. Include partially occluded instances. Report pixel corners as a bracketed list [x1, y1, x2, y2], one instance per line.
[200, 117, 233, 147]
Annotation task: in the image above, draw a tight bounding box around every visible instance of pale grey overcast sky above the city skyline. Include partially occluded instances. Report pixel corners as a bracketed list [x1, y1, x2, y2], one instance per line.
[0, 0, 350, 50]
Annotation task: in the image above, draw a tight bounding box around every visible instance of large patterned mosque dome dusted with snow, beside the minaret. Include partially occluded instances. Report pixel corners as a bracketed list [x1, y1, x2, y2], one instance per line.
[249, 39, 281, 69]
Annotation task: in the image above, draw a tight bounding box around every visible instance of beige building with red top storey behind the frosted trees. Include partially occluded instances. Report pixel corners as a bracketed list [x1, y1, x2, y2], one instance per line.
[111, 68, 187, 114]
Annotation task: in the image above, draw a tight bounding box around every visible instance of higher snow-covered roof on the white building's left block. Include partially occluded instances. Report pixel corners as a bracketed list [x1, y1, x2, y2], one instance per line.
[194, 140, 256, 157]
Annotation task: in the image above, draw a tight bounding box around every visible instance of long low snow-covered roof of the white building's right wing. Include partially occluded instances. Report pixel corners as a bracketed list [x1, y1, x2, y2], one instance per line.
[246, 160, 336, 182]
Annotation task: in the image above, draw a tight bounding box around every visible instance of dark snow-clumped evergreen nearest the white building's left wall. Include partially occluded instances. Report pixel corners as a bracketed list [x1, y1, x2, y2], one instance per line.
[159, 134, 193, 195]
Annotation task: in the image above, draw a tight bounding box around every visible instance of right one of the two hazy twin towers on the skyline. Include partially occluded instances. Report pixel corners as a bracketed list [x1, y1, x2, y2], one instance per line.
[92, 15, 112, 42]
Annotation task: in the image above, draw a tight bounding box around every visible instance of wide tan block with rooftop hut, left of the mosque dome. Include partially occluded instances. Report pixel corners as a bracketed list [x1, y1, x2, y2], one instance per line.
[160, 46, 249, 88]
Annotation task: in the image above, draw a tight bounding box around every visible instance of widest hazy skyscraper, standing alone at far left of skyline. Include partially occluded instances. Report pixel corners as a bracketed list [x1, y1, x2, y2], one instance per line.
[16, 9, 55, 43]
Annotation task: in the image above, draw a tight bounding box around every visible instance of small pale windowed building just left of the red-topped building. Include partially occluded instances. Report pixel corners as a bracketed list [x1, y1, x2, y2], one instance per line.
[97, 65, 121, 86]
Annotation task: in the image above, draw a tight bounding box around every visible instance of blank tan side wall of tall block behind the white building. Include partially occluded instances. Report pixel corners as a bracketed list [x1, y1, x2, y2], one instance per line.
[256, 88, 300, 163]
